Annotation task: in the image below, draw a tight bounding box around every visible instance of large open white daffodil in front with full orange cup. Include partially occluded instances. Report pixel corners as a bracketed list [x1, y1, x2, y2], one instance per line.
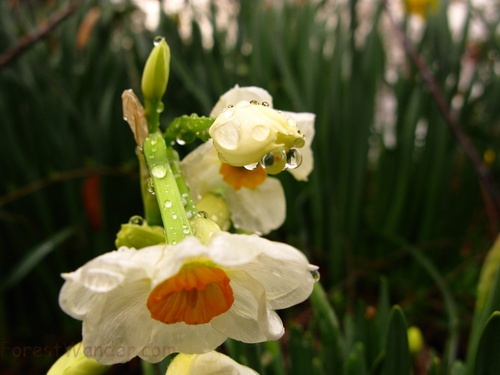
[59, 231, 317, 364]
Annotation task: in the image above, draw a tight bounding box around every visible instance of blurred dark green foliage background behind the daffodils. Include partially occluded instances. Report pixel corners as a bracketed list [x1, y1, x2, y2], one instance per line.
[0, 0, 500, 374]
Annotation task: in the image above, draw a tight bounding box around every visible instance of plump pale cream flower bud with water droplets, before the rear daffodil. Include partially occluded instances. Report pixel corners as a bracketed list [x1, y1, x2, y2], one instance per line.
[209, 101, 305, 167]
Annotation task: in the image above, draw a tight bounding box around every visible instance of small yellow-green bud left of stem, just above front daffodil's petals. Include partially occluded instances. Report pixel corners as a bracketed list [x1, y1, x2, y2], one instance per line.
[115, 216, 165, 249]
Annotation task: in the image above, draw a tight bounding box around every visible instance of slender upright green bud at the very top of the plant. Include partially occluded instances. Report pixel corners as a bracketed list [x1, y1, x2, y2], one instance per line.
[142, 37, 170, 101]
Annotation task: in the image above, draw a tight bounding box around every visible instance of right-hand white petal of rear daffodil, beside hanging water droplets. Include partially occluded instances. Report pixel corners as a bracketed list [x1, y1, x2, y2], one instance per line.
[286, 112, 316, 181]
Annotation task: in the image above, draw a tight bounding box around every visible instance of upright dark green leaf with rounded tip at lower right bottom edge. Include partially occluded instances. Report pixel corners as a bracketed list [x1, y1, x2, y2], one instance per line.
[382, 306, 410, 375]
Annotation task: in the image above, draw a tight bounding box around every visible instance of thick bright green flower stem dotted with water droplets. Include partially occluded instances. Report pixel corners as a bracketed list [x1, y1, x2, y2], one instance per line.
[143, 132, 192, 244]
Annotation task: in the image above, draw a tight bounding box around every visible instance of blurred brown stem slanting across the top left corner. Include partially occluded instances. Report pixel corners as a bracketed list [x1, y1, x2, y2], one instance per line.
[0, 3, 77, 69]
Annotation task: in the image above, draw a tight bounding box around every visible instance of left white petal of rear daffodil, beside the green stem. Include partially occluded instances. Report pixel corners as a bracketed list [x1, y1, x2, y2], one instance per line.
[181, 140, 221, 200]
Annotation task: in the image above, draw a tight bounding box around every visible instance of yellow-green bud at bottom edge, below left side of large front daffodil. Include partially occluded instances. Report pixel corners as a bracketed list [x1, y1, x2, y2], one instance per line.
[47, 342, 109, 375]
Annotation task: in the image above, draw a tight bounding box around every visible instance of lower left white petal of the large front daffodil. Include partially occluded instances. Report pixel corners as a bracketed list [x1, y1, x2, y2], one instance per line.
[82, 280, 154, 364]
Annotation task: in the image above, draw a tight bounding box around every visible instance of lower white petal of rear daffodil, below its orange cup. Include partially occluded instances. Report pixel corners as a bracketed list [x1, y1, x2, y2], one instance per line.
[226, 177, 286, 234]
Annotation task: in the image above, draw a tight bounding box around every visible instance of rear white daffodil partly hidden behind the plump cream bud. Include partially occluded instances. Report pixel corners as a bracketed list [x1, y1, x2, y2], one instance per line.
[181, 86, 314, 234]
